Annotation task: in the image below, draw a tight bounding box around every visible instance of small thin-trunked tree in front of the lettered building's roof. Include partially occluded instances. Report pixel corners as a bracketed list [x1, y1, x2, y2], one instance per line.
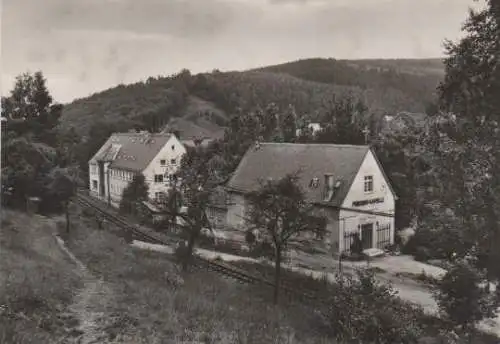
[246, 175, 326, 303]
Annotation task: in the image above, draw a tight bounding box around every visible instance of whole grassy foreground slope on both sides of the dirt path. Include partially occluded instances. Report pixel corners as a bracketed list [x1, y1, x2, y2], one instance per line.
[0, 209, 496, 344]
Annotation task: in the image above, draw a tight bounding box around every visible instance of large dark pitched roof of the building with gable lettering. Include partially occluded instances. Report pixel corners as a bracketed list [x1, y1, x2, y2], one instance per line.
[227, 143, 370, 206]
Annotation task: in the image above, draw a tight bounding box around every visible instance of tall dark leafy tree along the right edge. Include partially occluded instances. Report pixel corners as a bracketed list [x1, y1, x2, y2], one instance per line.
[429, 0, 500, 288]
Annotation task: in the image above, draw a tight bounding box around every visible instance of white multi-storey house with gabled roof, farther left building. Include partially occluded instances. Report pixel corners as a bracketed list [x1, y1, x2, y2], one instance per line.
[89, 131, 186, 206]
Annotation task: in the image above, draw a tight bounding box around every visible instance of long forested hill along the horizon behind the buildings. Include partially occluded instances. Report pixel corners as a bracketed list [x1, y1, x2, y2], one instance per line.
[56, 59, 443, 136]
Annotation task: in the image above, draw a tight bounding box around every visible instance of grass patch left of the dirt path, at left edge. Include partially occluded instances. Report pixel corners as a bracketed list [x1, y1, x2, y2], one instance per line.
[0, 210, 81, 344]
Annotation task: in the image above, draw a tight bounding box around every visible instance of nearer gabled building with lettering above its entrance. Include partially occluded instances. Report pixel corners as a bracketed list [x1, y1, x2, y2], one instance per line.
[226, 143, 396, 252]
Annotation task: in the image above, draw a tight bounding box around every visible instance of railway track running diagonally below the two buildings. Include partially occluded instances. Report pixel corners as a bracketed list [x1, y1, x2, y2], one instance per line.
[74, 191, 318, 301]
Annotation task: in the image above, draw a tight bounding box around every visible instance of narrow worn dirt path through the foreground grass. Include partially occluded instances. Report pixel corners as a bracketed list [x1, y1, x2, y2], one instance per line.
[56, 238, 113, 344]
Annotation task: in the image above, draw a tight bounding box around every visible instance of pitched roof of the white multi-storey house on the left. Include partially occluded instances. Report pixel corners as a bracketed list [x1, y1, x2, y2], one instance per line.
[90, 132, 172, 172]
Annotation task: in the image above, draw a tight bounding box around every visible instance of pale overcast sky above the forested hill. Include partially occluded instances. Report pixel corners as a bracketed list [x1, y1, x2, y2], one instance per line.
[1, 0, 484, 102]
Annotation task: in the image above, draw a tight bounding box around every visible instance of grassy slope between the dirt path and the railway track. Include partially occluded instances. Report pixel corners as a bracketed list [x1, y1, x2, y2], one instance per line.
[65, 208, 335, 344]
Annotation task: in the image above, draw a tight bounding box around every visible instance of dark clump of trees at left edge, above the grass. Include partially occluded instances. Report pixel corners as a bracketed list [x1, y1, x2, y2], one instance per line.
[1, 72, 78, 215]
